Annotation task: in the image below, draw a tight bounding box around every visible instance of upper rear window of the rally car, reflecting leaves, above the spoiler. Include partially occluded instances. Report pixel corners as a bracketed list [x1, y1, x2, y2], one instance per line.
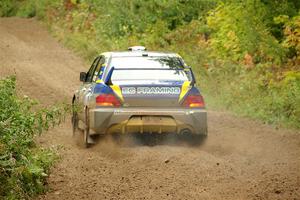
[110, 56, 184, 69]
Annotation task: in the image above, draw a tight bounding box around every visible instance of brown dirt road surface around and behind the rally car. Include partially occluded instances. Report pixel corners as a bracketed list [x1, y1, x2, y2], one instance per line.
[0, 18, 300, 200]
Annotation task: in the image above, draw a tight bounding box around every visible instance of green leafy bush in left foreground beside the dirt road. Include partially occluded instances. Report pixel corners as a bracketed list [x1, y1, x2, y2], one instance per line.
[0, 77, 66, 199]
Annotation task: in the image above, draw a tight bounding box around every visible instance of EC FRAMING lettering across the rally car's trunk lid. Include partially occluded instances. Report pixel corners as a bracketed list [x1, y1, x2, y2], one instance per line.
[122, 87, 180, 95]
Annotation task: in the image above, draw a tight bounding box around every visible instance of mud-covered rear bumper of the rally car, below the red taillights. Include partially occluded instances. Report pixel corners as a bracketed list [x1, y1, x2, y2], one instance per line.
[89, 108, 207, 135]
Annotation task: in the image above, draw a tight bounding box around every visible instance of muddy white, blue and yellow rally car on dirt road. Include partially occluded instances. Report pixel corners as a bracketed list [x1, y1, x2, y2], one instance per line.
[72, 46, 207, 147]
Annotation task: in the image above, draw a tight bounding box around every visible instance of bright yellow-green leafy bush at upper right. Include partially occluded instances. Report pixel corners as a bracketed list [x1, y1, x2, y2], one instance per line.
[207, 1, 284, 63]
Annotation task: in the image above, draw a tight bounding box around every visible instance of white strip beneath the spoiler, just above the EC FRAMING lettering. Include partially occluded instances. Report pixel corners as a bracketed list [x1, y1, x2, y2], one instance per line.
[111, 69, 188, 82]
